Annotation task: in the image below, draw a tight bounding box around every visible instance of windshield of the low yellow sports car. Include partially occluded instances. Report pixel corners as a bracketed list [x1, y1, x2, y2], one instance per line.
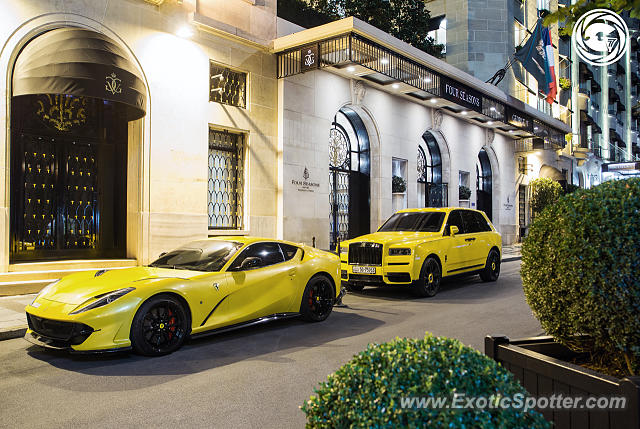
[149, 240, 242, 271]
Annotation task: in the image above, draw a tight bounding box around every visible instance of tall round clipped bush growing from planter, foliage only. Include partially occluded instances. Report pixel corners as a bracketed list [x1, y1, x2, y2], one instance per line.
[521, 179, 640, 374]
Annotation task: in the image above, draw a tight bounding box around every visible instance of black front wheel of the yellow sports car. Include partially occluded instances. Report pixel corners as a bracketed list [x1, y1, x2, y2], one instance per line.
[131, 295, 191, 356]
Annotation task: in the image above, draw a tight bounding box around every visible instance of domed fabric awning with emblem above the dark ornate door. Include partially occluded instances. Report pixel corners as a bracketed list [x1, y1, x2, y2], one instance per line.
[13, 28, 147, 121]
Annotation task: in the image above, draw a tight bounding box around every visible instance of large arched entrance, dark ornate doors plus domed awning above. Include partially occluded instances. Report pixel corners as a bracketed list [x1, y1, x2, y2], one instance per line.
[10, 28, 146, 262]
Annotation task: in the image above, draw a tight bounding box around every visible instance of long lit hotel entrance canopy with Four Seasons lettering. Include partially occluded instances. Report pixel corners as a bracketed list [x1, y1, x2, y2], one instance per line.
[272, 17, 571, 149]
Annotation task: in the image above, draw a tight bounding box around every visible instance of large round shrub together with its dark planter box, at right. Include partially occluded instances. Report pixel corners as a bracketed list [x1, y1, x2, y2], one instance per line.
[485, 179, 640, 428]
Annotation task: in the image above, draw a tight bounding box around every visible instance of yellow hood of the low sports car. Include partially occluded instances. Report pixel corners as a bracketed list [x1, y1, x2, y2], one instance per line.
[38, 267, 204, 305]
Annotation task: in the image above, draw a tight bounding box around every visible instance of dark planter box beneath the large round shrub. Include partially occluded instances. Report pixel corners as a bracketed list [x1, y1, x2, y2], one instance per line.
[484, 336, 640, 429]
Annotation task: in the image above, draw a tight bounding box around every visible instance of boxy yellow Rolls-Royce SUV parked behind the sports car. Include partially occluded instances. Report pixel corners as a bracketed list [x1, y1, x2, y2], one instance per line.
[340, 207, 502, 297]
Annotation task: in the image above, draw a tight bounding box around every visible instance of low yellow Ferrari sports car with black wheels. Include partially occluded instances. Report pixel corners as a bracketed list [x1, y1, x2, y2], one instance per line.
[25, 237, 340, 356]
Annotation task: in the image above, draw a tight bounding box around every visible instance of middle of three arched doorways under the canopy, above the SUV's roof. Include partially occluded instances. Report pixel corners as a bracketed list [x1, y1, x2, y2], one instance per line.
[418, 131, 448, 207]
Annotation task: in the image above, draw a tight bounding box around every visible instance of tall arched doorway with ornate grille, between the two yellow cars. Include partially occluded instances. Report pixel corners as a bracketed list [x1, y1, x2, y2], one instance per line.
[329, 107, 370, 249]
